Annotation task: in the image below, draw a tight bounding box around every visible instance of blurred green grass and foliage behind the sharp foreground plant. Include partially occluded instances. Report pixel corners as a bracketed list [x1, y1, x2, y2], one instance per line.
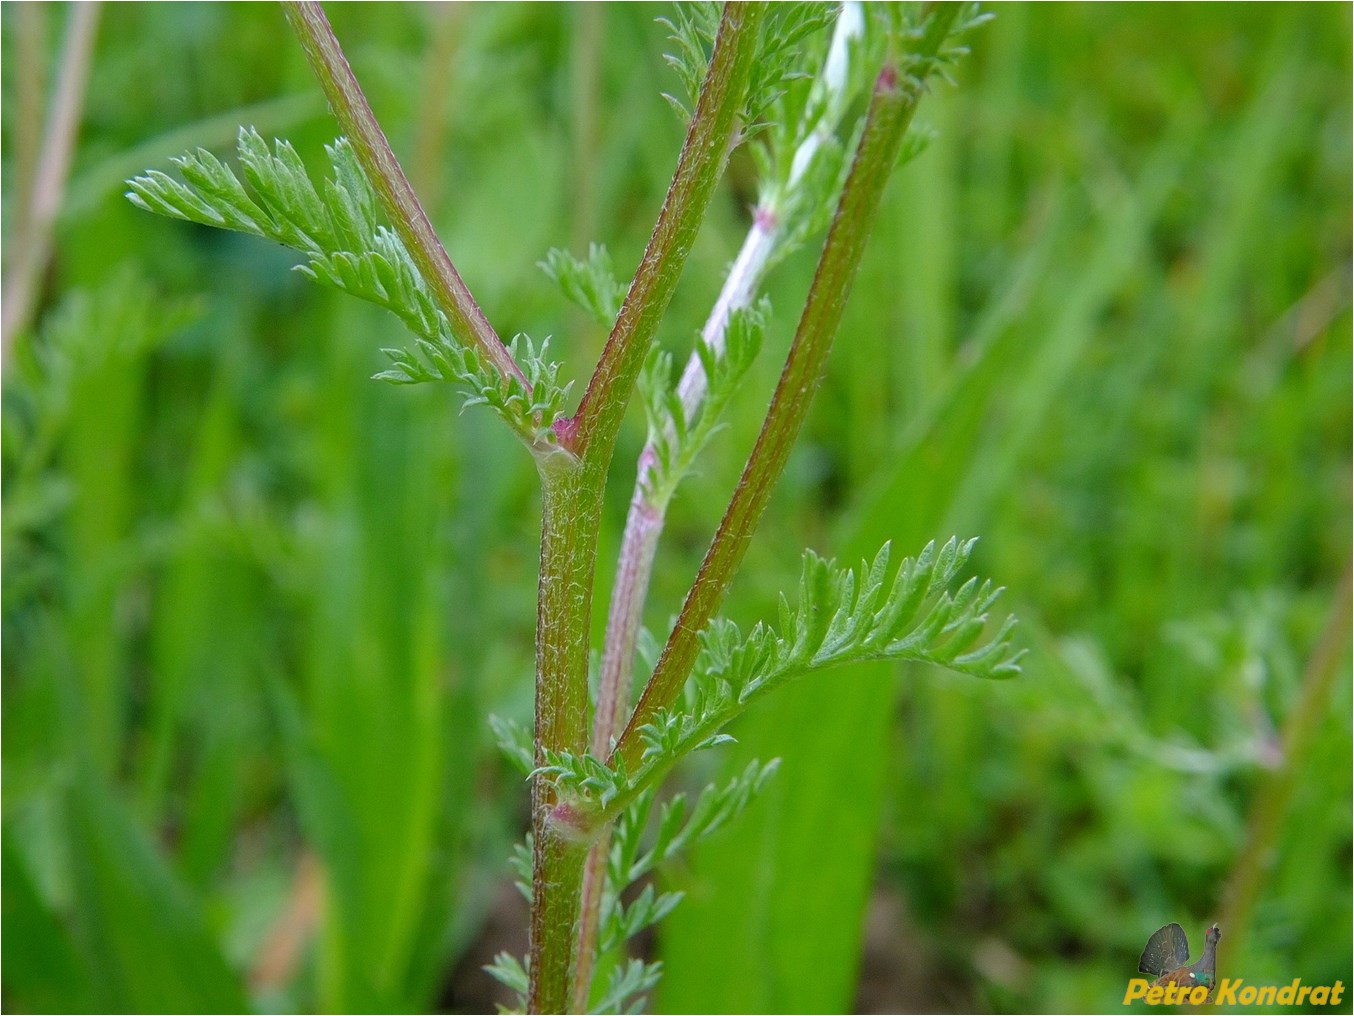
[3, 3, 1351, 1012]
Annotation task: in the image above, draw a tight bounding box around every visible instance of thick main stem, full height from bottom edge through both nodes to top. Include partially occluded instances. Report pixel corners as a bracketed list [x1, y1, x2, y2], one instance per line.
[527, 11, 765, 1012]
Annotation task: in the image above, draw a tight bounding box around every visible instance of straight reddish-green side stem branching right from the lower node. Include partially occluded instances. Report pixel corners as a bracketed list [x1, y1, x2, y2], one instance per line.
[612, 4, 957, 767]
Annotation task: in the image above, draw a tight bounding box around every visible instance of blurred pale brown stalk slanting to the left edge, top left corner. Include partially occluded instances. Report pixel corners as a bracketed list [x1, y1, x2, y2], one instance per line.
[0, 3, 99, 359]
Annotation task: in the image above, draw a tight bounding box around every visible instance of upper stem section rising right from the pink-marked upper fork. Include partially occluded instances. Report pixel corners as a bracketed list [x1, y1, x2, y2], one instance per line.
[566, 3, 766, 465]
